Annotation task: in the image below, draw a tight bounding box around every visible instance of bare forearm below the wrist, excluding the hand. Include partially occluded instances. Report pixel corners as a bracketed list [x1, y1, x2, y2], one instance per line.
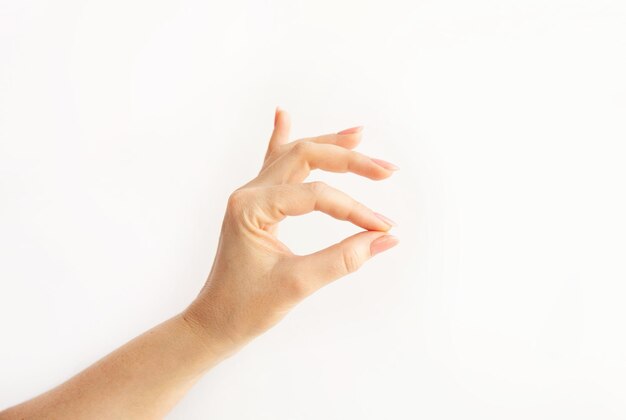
[0, 314, 235, 419]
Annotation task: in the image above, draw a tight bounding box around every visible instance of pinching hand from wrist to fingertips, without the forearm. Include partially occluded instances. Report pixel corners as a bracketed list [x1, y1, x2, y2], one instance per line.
[183, 109, 398, 354]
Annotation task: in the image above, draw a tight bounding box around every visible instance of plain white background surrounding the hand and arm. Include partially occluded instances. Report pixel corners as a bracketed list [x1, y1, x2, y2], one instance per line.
[0, 0, 626, 420]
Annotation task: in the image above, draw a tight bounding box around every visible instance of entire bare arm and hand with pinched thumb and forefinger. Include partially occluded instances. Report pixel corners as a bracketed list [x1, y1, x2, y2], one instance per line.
[0, 109, 398, 420]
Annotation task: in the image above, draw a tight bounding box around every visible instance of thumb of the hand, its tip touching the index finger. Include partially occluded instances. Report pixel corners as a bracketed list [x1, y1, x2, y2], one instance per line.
[294, 231, 399, 287]
